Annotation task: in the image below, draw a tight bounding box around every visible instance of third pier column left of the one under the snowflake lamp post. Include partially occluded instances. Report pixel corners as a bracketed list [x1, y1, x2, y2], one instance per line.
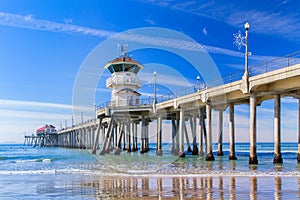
[205, 104, 215, 161]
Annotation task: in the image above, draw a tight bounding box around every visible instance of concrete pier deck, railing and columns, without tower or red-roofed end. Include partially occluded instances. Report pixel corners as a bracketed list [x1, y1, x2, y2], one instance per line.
[57, 52, 300, 164]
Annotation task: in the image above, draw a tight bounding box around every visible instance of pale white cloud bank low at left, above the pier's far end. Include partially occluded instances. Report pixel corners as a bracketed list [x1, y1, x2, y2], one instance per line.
[0, 99, 97, 142]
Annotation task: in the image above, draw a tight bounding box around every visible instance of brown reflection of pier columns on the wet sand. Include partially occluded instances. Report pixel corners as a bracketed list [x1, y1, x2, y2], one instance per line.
[73, 175, 300, 200]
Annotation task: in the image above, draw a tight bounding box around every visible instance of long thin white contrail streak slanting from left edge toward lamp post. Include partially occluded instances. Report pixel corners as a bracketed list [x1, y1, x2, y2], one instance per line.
[0, 11, 278, 60]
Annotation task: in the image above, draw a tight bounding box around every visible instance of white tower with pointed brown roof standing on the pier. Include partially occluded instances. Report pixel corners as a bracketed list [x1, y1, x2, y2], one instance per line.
[104, 49, 144, 107]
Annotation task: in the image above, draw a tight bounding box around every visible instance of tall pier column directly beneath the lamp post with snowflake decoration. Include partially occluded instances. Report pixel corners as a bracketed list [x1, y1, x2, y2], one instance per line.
[249, 94, 258, 164]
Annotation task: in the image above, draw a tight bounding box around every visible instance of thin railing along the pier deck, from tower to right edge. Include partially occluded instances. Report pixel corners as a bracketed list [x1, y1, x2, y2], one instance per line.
[98, 51, 300, 109]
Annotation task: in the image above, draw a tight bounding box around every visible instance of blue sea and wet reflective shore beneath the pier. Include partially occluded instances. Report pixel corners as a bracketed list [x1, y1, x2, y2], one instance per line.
[0, 143, 300, 199]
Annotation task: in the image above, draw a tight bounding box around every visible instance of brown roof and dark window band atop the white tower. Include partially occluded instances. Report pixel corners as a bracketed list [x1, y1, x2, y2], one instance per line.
[104, 56, 144, 74]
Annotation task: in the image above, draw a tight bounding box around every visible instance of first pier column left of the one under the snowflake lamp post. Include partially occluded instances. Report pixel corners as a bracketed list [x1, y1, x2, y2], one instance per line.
[229, 103, 237, 160]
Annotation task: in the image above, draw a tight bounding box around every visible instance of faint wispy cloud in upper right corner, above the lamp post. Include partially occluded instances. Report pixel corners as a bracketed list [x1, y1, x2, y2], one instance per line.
[142, 0, 300, 41]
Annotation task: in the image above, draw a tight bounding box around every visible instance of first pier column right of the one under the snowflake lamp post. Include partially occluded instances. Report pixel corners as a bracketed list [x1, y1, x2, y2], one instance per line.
[273, 94, 282, 164]
